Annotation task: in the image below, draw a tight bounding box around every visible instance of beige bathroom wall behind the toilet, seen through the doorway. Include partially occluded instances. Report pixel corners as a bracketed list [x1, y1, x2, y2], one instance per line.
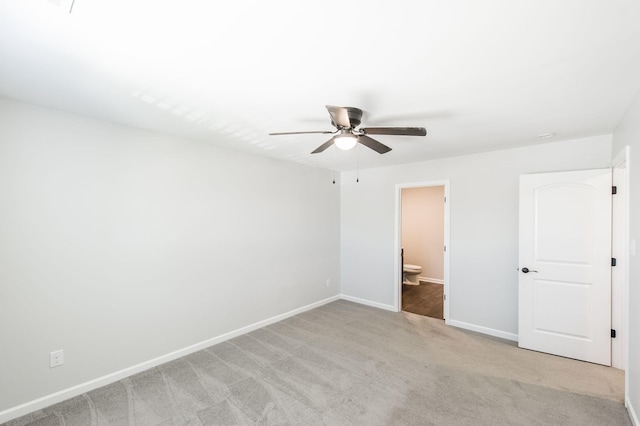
[402, 186, 444, 282]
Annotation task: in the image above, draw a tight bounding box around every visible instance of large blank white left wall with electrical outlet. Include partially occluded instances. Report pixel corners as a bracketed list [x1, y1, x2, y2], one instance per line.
[0, 98, 340, 416]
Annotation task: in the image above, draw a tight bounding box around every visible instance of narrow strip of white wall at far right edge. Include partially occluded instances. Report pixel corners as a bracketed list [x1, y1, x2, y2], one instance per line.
[612, 90, 640, 425]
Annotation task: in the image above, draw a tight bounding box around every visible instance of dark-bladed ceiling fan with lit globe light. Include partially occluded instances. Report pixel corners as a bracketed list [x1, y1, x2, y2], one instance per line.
[269, 105, 427, 154]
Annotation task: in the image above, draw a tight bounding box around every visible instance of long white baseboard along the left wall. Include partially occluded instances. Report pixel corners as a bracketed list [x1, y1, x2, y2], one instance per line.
[0, 295, 341, 424]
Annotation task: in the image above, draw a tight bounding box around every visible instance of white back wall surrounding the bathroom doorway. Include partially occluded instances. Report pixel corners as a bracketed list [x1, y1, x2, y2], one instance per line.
[340, 136, 611, 336]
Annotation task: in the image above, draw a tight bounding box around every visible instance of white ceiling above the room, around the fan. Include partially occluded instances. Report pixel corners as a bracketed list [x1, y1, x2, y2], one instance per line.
[0, 0, 640, 170]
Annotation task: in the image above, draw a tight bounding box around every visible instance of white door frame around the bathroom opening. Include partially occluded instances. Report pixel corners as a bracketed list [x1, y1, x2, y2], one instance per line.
[393, 179, 451, 324]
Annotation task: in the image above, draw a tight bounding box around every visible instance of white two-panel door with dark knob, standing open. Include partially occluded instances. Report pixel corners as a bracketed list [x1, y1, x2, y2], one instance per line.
[518, 169, 611, 365]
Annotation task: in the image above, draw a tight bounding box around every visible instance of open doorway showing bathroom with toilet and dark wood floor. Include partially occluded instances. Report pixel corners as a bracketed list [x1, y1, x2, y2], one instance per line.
[398, 182, 448, 319]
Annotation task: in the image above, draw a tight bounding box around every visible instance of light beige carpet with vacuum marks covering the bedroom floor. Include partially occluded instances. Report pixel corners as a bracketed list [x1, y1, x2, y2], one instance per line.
[3, 301, 631, 426]
